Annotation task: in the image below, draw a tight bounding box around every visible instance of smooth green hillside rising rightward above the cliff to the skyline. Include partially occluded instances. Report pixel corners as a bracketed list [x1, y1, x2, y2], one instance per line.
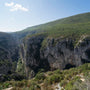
[15, 12, 90, 38]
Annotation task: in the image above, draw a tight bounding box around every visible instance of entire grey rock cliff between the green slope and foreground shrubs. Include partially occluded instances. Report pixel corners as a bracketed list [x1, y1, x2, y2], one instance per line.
[20, 36, 90, 77]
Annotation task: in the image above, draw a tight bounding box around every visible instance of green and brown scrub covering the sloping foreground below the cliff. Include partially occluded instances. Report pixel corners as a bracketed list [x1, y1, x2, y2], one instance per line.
[0, 63, 90, 90]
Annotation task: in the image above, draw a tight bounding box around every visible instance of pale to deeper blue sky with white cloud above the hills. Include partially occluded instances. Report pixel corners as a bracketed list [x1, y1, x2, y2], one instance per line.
[0, 0, 90, 32]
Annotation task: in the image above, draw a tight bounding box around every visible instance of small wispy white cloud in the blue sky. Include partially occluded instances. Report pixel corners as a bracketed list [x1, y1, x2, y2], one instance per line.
[5, 2, 29, 12]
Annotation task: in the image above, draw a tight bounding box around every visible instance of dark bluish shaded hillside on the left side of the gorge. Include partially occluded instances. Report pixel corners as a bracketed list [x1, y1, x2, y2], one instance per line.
[0, 32, 18, 74]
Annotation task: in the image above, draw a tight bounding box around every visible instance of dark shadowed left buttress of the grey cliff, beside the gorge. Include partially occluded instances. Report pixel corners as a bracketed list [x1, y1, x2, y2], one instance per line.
[20, 36, 49, 77]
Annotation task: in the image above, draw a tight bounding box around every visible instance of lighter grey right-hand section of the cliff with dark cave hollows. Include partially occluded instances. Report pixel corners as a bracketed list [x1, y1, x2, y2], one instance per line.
[41, 39, 90, 70]
